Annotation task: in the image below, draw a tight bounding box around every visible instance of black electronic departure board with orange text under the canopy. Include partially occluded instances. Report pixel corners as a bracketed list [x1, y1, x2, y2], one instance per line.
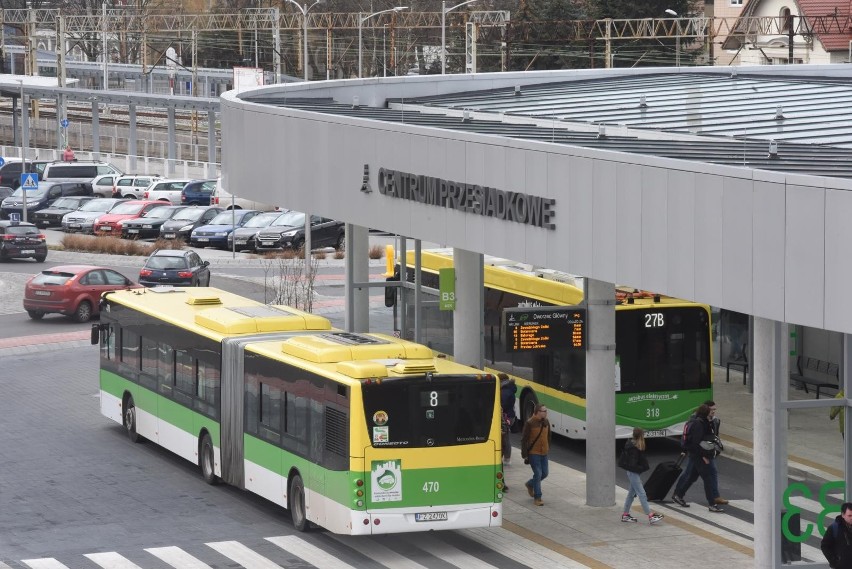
[503, 306, 586, 352]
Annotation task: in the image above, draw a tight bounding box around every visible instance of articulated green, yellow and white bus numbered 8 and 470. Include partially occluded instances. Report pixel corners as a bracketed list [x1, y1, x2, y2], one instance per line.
[92, 288, 504, 534]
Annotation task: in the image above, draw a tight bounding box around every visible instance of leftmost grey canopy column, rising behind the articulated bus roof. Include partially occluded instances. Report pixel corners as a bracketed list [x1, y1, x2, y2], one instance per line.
[344, 223, 370, 332]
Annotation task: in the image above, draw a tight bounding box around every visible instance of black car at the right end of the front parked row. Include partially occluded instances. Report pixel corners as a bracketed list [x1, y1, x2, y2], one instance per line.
[257, 211, 346, 251]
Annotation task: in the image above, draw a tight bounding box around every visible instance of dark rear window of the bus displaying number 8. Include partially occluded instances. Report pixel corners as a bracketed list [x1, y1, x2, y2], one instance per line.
[362, 375, 496, 448]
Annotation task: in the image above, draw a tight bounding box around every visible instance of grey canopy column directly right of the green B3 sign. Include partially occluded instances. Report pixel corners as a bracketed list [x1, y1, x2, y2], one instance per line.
[453, 249, 485, 369]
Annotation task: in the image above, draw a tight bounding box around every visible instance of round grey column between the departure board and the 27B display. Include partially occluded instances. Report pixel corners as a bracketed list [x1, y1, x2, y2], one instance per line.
[585, 279, 615, 507]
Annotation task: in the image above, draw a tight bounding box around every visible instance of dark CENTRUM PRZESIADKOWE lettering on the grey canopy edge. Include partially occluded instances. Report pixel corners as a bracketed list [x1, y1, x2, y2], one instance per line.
[378, 168, 556, 229]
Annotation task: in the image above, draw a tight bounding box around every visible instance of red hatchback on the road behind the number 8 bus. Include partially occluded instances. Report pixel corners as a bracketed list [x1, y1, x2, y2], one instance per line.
[24, 265, 140, 322]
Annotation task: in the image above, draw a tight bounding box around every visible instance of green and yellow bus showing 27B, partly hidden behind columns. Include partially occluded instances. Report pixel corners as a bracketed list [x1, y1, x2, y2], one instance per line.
[396, 249, 713, 439]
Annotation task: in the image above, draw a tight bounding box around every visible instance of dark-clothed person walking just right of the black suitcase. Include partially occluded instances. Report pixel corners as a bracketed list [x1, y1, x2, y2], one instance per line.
[672, 401, 728, 513]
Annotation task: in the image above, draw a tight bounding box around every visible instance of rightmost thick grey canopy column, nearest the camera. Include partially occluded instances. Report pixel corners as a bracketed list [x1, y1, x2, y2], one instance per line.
[752, 318, 789, 567]
